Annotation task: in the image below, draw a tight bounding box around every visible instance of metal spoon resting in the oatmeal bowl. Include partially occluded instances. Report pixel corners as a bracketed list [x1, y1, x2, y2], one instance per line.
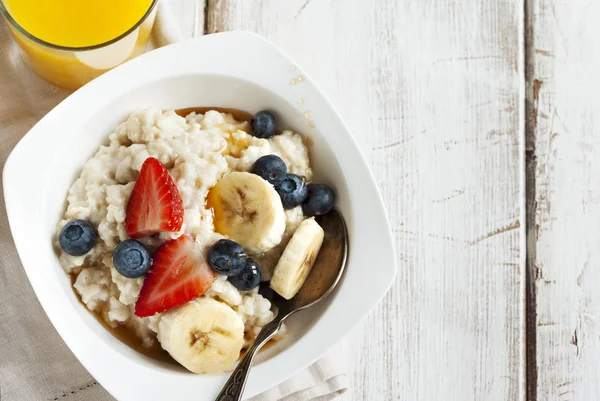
[215, 211, 348, 401]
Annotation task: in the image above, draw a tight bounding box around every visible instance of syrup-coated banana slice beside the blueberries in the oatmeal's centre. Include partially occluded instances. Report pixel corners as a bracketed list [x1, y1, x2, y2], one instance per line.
[207, 172, 285, 253]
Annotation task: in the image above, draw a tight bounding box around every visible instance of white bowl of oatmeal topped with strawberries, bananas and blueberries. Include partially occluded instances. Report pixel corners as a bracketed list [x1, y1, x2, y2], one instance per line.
[4, 33, 396, 400]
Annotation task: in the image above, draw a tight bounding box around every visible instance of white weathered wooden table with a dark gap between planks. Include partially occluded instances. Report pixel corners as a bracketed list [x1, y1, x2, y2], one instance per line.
[171, 0, 600, 401]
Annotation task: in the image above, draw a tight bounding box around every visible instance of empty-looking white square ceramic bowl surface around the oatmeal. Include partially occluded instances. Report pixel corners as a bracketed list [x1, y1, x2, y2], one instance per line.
[3, 32, 396, 401]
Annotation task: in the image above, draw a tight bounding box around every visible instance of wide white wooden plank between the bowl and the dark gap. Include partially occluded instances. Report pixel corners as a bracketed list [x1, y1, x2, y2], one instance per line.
[207, 0, 525, 400]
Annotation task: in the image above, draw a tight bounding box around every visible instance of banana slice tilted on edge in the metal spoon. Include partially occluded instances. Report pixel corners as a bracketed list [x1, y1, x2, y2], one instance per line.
[271, 217, 325, 299]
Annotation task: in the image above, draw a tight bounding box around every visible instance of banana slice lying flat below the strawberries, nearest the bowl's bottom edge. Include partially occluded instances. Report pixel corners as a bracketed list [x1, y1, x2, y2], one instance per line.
[158, 297, 244, 373]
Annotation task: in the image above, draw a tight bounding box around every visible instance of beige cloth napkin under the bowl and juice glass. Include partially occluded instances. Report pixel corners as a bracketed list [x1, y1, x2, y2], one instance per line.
[0, 3, 348, 401]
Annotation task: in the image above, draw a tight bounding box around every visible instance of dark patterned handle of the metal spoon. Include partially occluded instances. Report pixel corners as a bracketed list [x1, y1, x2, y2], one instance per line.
[215, 316, 283, 401]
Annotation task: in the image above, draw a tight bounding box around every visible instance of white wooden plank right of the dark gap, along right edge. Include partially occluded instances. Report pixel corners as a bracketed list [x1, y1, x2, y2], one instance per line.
[528, 0, 600, 401]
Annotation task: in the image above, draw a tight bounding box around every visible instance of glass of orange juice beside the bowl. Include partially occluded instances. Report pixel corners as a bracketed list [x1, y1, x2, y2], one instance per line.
[0, 0, 158, 90]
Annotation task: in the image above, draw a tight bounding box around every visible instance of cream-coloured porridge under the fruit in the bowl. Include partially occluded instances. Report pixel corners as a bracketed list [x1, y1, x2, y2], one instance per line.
[57, 109, 332, 374]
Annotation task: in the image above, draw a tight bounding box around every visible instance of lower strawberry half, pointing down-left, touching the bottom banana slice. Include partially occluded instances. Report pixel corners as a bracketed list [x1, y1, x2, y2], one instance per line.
[135, 235, 216, 317]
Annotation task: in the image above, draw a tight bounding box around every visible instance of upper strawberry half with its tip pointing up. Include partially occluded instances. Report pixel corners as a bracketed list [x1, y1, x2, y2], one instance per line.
[125, 157, 183, 238]
